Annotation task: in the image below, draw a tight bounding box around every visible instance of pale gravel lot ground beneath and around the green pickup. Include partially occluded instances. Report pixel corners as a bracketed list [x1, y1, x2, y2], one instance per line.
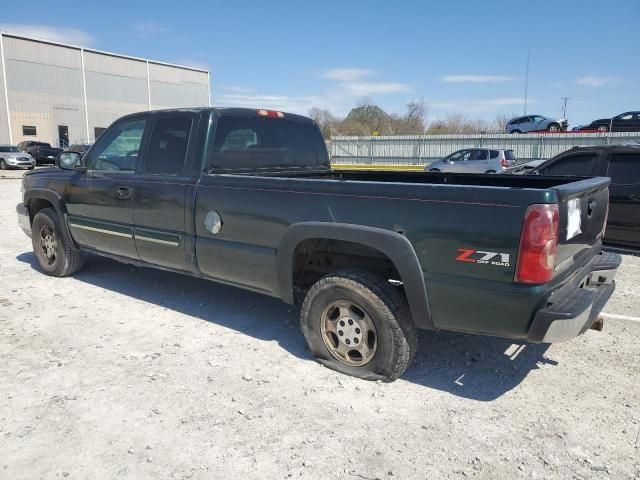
[0, 174, 640, 480]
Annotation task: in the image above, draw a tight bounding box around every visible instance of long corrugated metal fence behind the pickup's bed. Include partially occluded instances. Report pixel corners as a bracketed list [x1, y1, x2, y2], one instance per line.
[331, 132, 640, 165]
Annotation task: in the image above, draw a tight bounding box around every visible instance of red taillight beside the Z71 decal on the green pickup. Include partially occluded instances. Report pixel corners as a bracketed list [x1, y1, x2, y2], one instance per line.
[514, 204, 560, 283]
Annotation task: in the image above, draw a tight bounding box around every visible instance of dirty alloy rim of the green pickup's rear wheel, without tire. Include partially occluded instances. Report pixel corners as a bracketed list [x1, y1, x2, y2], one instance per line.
[320, 300, 378, 367]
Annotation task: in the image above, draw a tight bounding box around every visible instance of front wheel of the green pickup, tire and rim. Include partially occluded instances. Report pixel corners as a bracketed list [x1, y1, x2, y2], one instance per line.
[31, 208, 83, 277]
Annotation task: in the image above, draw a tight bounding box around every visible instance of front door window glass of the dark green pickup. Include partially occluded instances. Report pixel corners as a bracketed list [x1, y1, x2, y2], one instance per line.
[87, 119, 147, 173]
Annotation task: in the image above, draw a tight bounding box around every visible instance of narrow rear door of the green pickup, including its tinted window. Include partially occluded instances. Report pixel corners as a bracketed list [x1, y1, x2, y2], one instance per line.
[133, 113, 197, 270]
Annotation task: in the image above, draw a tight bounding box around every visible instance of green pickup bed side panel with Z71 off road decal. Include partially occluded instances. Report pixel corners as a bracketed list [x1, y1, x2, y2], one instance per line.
[195, 175, 554, 337]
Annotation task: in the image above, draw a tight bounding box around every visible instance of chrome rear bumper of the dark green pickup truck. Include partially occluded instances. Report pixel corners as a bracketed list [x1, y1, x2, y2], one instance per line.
[527, 253, 622, 343]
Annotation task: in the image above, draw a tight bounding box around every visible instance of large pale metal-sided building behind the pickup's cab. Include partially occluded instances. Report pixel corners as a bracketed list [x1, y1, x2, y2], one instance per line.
[0, 32, 211, 146]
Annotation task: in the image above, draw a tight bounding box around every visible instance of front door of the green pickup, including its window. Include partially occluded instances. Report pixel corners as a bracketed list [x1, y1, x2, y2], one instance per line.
[65, 116, 147, 258]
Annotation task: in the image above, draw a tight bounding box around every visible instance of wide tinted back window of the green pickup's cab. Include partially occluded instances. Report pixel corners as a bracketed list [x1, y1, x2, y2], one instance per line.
[209, 116, 328, 173]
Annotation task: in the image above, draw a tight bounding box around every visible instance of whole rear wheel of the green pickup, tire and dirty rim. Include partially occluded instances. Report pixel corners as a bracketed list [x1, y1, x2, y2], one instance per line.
[300, 270, 418, 382]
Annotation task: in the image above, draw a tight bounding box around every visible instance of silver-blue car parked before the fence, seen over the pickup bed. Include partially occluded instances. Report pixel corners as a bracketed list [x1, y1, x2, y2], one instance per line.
[425, 148, 516, 173]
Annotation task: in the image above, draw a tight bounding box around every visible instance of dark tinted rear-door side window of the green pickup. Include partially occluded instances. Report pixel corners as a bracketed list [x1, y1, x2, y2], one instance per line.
[144, 116, 192, 175]
